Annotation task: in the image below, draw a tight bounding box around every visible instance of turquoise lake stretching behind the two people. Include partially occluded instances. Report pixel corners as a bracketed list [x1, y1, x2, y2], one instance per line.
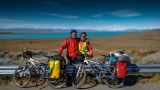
[0, 32, 126, 39]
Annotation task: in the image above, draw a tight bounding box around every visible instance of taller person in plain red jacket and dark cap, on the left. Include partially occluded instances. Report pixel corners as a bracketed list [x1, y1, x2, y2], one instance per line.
[58, 30, 80, 64]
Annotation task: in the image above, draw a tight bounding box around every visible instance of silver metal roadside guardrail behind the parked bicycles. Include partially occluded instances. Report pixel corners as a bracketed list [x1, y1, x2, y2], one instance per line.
[0, 64, 160, 75]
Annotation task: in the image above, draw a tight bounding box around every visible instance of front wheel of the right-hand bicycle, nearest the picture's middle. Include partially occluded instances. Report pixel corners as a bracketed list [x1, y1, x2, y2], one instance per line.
[73, 67, 86, 89]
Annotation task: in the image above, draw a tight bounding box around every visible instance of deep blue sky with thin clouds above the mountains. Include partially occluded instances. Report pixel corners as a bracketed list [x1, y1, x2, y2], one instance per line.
[0, 0, 160, 31]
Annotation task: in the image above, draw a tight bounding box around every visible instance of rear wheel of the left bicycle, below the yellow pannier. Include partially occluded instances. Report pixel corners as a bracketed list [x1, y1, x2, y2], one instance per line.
[47, 71, 67, 89]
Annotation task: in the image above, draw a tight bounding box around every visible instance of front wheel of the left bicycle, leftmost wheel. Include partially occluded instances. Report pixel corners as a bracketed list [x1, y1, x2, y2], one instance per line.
[13, 66, 31, 87]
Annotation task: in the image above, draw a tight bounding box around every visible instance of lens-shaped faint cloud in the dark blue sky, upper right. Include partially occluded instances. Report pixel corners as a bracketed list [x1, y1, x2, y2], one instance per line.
[110, 9, 141, 17]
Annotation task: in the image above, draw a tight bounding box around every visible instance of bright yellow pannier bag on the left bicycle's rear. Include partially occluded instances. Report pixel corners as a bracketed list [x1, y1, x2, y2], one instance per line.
[49, 60, 61, 79]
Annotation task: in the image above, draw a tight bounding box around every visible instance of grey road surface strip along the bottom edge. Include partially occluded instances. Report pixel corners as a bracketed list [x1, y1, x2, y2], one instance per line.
[0, 83, 160, 90]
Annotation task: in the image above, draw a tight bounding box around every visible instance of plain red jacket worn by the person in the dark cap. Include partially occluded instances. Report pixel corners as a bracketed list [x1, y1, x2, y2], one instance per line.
[58, 37, 80, 58]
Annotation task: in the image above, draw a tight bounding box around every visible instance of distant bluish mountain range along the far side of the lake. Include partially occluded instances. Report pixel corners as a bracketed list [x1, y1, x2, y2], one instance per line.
[0, 28, 158, 33]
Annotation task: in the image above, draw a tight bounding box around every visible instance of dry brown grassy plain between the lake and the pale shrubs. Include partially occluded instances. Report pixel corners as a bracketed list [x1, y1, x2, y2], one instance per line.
[0, 30, 160, 54]
